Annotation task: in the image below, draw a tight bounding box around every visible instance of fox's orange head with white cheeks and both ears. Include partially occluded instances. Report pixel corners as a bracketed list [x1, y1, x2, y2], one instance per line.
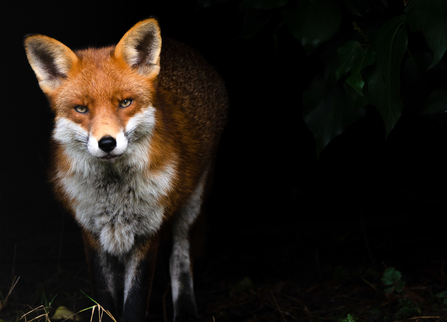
[25, 18, 161, 162]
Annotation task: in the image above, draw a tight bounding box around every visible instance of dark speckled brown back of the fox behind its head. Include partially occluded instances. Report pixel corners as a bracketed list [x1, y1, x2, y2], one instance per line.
[159, 38, 228, 156]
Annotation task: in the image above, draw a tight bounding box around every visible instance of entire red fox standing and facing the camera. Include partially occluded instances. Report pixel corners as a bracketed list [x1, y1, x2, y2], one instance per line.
[24, 18, 228, 322]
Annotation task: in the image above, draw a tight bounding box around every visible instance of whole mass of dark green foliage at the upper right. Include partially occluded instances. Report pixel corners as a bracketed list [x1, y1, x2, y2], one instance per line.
[198, 0, 447, 155]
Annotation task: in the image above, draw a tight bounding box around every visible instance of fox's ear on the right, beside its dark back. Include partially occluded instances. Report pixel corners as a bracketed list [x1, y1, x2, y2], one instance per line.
[115, 18, 161, 76]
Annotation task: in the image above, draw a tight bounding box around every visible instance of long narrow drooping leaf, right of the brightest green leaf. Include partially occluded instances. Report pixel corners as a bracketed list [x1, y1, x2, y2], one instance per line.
[368, 15, 407, 136]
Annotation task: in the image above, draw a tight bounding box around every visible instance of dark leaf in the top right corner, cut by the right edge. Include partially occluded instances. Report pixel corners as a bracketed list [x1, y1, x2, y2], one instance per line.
[405, 0, 447, 69]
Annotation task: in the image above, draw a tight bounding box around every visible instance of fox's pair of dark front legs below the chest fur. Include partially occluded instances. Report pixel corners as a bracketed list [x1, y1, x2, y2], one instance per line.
[83, 232, 159, 322]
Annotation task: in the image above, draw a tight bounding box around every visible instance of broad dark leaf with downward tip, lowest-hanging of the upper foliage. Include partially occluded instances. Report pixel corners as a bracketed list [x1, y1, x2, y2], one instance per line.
[303, 75, 362, 156]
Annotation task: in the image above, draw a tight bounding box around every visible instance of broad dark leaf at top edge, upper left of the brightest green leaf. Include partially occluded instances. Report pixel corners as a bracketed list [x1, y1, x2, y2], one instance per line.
[282, 0, 341, 54]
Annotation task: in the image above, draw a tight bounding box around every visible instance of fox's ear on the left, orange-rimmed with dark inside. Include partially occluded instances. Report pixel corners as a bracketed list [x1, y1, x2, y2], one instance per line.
[24, 35, 78, 93]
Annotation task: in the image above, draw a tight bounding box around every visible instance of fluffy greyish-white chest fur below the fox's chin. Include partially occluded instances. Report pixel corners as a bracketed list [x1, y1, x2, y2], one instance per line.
[61, 160, 174, 255]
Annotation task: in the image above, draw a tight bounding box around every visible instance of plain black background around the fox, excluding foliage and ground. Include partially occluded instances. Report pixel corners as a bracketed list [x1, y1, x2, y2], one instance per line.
[0, 1, 447, 320]
